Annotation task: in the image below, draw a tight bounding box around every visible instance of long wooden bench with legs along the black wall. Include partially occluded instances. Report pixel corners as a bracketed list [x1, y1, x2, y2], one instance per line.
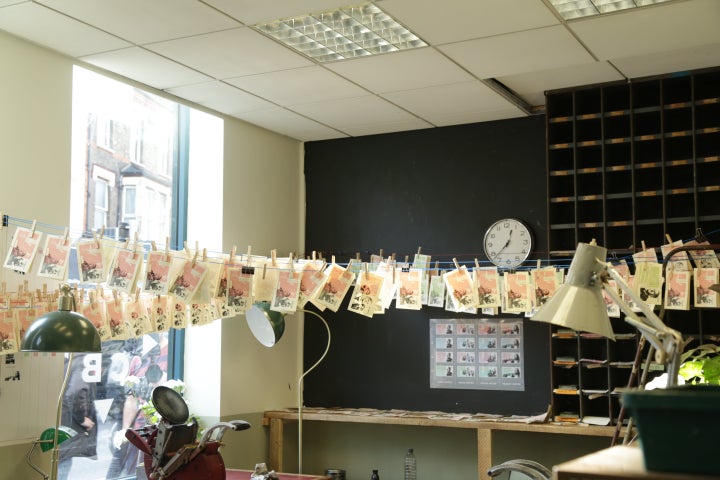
[263, 408, 615, 480]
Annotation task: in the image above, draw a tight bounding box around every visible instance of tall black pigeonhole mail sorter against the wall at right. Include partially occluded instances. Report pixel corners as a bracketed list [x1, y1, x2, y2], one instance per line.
[546, 69, 720, 422]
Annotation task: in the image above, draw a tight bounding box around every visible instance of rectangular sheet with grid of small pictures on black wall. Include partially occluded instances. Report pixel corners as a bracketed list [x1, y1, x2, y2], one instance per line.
[430, 318, 525, 391]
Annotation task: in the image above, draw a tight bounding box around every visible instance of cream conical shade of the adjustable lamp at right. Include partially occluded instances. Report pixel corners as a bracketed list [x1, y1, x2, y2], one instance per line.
[532, 243, 615, 340]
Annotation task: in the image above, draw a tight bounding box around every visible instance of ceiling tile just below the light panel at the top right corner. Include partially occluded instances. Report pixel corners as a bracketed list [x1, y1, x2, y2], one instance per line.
[568, 0, 720, 60]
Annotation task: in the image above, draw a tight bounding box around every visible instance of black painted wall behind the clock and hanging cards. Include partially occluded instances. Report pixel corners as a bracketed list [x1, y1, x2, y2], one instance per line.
[304, 116, 550, 414]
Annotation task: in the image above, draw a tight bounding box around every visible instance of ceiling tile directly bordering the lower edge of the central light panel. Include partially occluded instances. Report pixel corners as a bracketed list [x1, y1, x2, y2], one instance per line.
[327, 48, 473, 93]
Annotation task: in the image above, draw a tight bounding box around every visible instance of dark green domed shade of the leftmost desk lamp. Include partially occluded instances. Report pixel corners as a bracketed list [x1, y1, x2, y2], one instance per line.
[20, 286, 102, 353]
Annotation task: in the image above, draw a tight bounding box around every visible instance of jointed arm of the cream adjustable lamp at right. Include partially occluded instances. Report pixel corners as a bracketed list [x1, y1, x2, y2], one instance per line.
[602, 263, 685, 387]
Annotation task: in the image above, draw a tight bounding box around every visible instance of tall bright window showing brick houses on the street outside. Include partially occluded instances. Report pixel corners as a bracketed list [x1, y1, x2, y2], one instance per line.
[67, 67, 223, 480]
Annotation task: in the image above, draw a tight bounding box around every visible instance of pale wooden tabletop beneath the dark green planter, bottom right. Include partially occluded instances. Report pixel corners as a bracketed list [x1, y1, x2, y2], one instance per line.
[553, 445, 718, 480]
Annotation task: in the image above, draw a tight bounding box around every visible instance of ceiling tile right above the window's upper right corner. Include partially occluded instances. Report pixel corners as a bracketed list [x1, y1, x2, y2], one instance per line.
[166, 81, 273, 115]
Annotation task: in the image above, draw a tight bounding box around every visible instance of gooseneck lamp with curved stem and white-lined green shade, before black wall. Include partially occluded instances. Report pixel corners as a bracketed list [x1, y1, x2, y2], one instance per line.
[245, 302, 331, 473]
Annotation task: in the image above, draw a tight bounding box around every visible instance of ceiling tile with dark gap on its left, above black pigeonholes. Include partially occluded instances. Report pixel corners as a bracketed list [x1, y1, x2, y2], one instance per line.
[496, 62, 624, 106]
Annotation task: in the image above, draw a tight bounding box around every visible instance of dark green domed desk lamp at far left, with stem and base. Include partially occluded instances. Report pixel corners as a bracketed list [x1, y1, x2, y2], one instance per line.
[20, 285, 101, 480]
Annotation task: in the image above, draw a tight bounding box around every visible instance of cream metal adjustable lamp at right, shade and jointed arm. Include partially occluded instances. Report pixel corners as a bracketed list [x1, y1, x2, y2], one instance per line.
[532, 241, 684, 387]
